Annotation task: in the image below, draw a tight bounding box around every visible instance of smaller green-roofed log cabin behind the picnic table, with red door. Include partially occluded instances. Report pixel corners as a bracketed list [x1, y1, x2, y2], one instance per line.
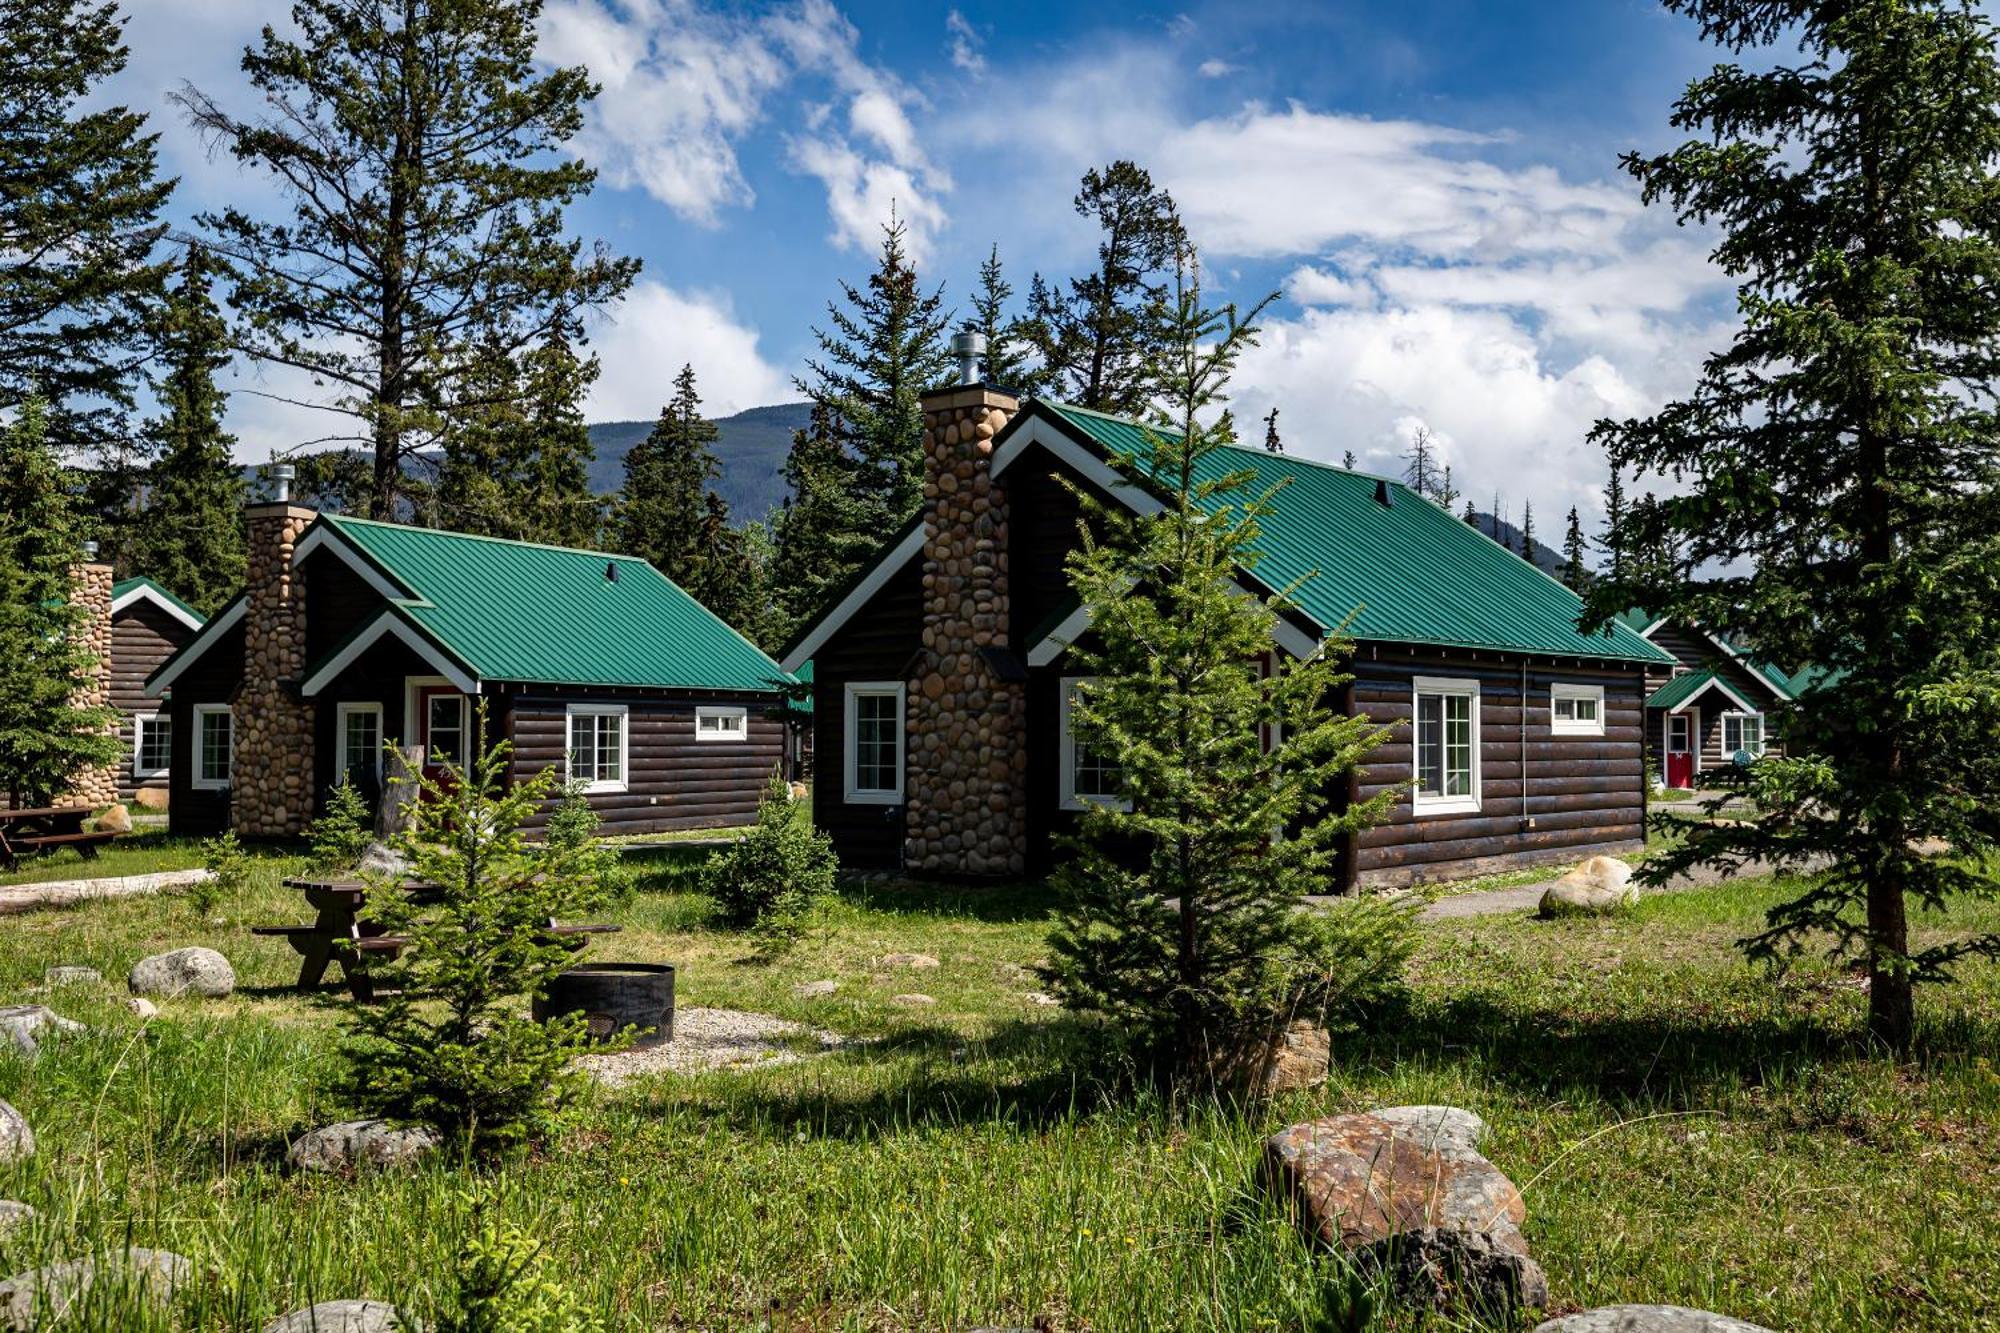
[146, 500, 790, 837]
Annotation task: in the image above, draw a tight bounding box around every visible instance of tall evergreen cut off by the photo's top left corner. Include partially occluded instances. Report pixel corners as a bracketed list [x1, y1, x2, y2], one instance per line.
[0, 0, 174, 452]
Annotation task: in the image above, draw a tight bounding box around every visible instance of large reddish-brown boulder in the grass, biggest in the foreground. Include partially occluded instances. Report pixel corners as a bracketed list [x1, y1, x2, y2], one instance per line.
[1264, 1107, 1548, 1309]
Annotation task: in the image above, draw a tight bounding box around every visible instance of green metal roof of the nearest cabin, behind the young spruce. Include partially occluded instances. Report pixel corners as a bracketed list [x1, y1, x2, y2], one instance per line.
[1042, 402, 1674, 662]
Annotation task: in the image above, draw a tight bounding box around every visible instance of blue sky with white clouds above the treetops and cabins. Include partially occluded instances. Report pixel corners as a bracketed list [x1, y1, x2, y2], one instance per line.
[114, 0, 1732, 540]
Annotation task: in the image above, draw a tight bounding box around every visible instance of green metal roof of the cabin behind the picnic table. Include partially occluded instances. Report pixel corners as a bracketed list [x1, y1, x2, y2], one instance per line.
[308, 514, 788, 691]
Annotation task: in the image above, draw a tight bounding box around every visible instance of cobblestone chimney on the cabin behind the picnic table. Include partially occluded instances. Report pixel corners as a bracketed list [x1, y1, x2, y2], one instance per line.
[230, 498, 318, 839]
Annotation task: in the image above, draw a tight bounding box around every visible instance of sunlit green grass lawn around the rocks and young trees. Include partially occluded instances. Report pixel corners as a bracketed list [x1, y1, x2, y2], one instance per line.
[0, 849, 2000, 1333]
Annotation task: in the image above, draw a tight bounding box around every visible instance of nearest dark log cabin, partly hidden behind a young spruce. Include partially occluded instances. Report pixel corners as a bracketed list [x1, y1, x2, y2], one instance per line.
[780, 374, 1674, 891]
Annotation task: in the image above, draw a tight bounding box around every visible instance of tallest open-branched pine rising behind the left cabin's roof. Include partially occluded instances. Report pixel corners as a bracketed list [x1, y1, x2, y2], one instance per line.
[178, 0, 638, 526]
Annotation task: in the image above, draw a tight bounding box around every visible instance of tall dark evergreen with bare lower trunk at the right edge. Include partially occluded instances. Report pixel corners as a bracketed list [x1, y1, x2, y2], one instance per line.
[1594, 0, 2000, 1051]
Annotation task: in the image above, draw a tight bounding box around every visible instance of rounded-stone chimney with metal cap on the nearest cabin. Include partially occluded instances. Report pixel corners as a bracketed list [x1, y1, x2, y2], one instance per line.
[904, 334, 1028, 875]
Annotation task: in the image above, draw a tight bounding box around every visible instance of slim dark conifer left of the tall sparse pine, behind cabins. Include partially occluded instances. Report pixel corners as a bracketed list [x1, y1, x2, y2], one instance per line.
[124, 244, 244, 614]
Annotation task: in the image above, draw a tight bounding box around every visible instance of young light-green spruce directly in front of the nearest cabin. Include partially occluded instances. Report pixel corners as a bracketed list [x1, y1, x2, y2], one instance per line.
[1048, 254, 1388, 1081]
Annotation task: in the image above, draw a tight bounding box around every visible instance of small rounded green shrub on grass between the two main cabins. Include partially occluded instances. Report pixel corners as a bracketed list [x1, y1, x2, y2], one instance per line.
[702, 777, 840, 957]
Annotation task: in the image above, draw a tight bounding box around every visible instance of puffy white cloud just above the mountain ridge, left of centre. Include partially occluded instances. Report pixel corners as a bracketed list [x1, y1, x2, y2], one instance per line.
[586, 280, 792, 420]
